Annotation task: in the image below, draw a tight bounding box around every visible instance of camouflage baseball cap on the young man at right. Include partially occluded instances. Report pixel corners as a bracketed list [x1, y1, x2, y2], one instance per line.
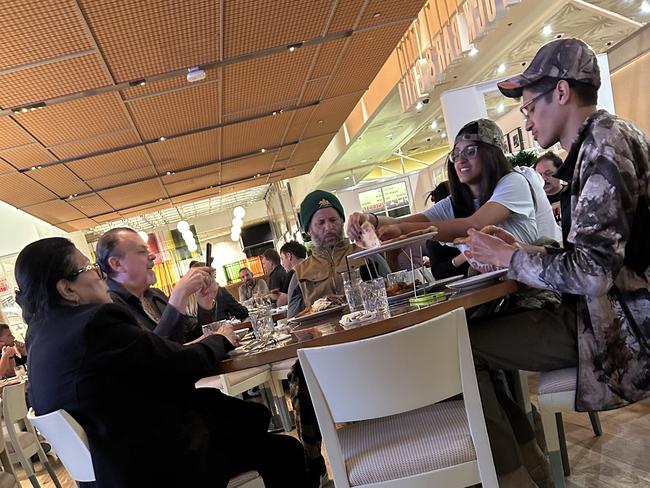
[497, 38, 600, 98]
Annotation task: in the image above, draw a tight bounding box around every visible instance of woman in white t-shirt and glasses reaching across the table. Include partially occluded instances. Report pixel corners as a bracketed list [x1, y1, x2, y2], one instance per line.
[348, 119, 550, 252]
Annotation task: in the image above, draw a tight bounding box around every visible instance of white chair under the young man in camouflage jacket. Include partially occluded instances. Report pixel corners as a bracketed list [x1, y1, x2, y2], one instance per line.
[537, 368, 602, 488]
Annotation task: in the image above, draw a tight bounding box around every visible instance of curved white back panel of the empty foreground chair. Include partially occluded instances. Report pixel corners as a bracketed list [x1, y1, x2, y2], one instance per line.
[298, 309, 474, 422]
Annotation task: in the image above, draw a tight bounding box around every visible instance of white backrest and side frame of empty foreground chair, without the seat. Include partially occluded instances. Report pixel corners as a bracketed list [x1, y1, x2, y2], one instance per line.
[298, 308, 497, 486]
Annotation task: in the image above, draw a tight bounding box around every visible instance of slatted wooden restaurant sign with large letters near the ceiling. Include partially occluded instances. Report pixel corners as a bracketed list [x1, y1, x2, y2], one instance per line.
[398, 0, 521, 112]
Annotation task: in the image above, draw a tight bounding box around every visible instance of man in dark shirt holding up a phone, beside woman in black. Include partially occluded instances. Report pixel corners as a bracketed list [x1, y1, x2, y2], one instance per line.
[96, 227, 214, 343]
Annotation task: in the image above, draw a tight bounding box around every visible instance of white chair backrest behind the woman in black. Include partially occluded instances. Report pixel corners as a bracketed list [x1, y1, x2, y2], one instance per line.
[27, 410, 95, 481]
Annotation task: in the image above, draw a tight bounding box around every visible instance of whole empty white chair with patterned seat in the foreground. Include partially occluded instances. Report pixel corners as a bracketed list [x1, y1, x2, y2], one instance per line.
[298, 309, 498, 488]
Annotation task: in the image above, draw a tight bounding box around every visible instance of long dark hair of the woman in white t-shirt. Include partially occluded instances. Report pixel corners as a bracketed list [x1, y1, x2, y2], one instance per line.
[447, 124, 512, 218]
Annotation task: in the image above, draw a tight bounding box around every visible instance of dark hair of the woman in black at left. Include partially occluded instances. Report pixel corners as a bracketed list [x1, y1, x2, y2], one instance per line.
[15, 237, 77, 323]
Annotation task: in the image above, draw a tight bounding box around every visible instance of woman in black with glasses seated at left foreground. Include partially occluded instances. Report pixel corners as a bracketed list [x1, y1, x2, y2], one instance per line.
[15, 237, 305, 488]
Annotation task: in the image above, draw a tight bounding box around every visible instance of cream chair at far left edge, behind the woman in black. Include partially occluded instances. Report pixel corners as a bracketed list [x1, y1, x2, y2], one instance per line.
[2, 383, 61, 488]
